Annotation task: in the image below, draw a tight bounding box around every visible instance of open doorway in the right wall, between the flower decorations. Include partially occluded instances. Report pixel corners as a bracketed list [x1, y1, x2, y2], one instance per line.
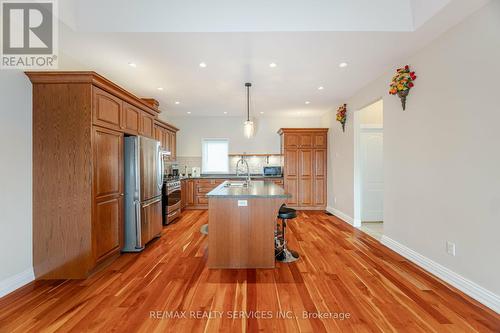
[354, 100, 384, 240]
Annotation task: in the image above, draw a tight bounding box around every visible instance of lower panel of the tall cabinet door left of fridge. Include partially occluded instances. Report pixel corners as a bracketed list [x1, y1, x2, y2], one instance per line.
[93, 196, 123, 261]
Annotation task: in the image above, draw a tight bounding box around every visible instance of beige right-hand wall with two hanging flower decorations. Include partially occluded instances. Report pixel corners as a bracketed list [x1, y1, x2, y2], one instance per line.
[323, 1, 500, 301]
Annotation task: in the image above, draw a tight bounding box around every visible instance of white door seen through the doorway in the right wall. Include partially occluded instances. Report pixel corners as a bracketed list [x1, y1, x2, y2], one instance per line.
[360, 129, 384, 222]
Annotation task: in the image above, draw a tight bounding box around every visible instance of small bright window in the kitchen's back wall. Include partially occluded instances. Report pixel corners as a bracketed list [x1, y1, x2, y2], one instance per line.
[201, 139, 229, 173]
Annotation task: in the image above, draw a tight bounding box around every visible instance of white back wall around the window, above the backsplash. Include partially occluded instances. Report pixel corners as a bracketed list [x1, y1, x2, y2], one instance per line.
[166, 117, 321, 156]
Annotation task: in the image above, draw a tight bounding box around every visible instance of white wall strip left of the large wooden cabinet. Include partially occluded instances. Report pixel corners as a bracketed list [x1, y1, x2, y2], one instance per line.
[0, 70, 33, 296]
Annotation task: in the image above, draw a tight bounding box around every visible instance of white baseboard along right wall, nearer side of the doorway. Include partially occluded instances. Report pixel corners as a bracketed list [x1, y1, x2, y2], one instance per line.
[381, 235, 500, 313]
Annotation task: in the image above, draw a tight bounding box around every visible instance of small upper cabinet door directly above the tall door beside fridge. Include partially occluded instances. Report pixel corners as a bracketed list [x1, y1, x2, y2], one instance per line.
[92, 87, 122, 130]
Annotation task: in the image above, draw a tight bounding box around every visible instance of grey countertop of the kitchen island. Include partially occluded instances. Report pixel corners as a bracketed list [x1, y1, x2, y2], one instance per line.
[207, 180, 291, 198]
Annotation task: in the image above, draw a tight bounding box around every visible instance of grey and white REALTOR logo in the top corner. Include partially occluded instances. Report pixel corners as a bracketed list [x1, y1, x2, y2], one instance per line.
[1, 0, 57, 69]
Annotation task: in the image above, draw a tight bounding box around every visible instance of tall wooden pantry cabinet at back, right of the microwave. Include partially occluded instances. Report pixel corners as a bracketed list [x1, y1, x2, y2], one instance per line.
[278, 128, 328, 210]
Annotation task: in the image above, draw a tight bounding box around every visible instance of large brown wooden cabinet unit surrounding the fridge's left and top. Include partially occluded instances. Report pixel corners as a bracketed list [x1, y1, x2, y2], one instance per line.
[26, 72, 175, 279]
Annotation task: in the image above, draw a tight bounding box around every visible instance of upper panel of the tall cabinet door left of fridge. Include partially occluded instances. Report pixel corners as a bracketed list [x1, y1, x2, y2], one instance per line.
[94, 127, 123, 198]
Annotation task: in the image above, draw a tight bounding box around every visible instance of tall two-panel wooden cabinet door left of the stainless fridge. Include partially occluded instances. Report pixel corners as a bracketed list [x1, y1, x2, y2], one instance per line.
[92, 127, 123, 261]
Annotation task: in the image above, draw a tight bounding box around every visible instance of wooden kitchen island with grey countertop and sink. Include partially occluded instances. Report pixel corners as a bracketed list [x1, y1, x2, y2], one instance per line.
[207, 181, 290, 268]
